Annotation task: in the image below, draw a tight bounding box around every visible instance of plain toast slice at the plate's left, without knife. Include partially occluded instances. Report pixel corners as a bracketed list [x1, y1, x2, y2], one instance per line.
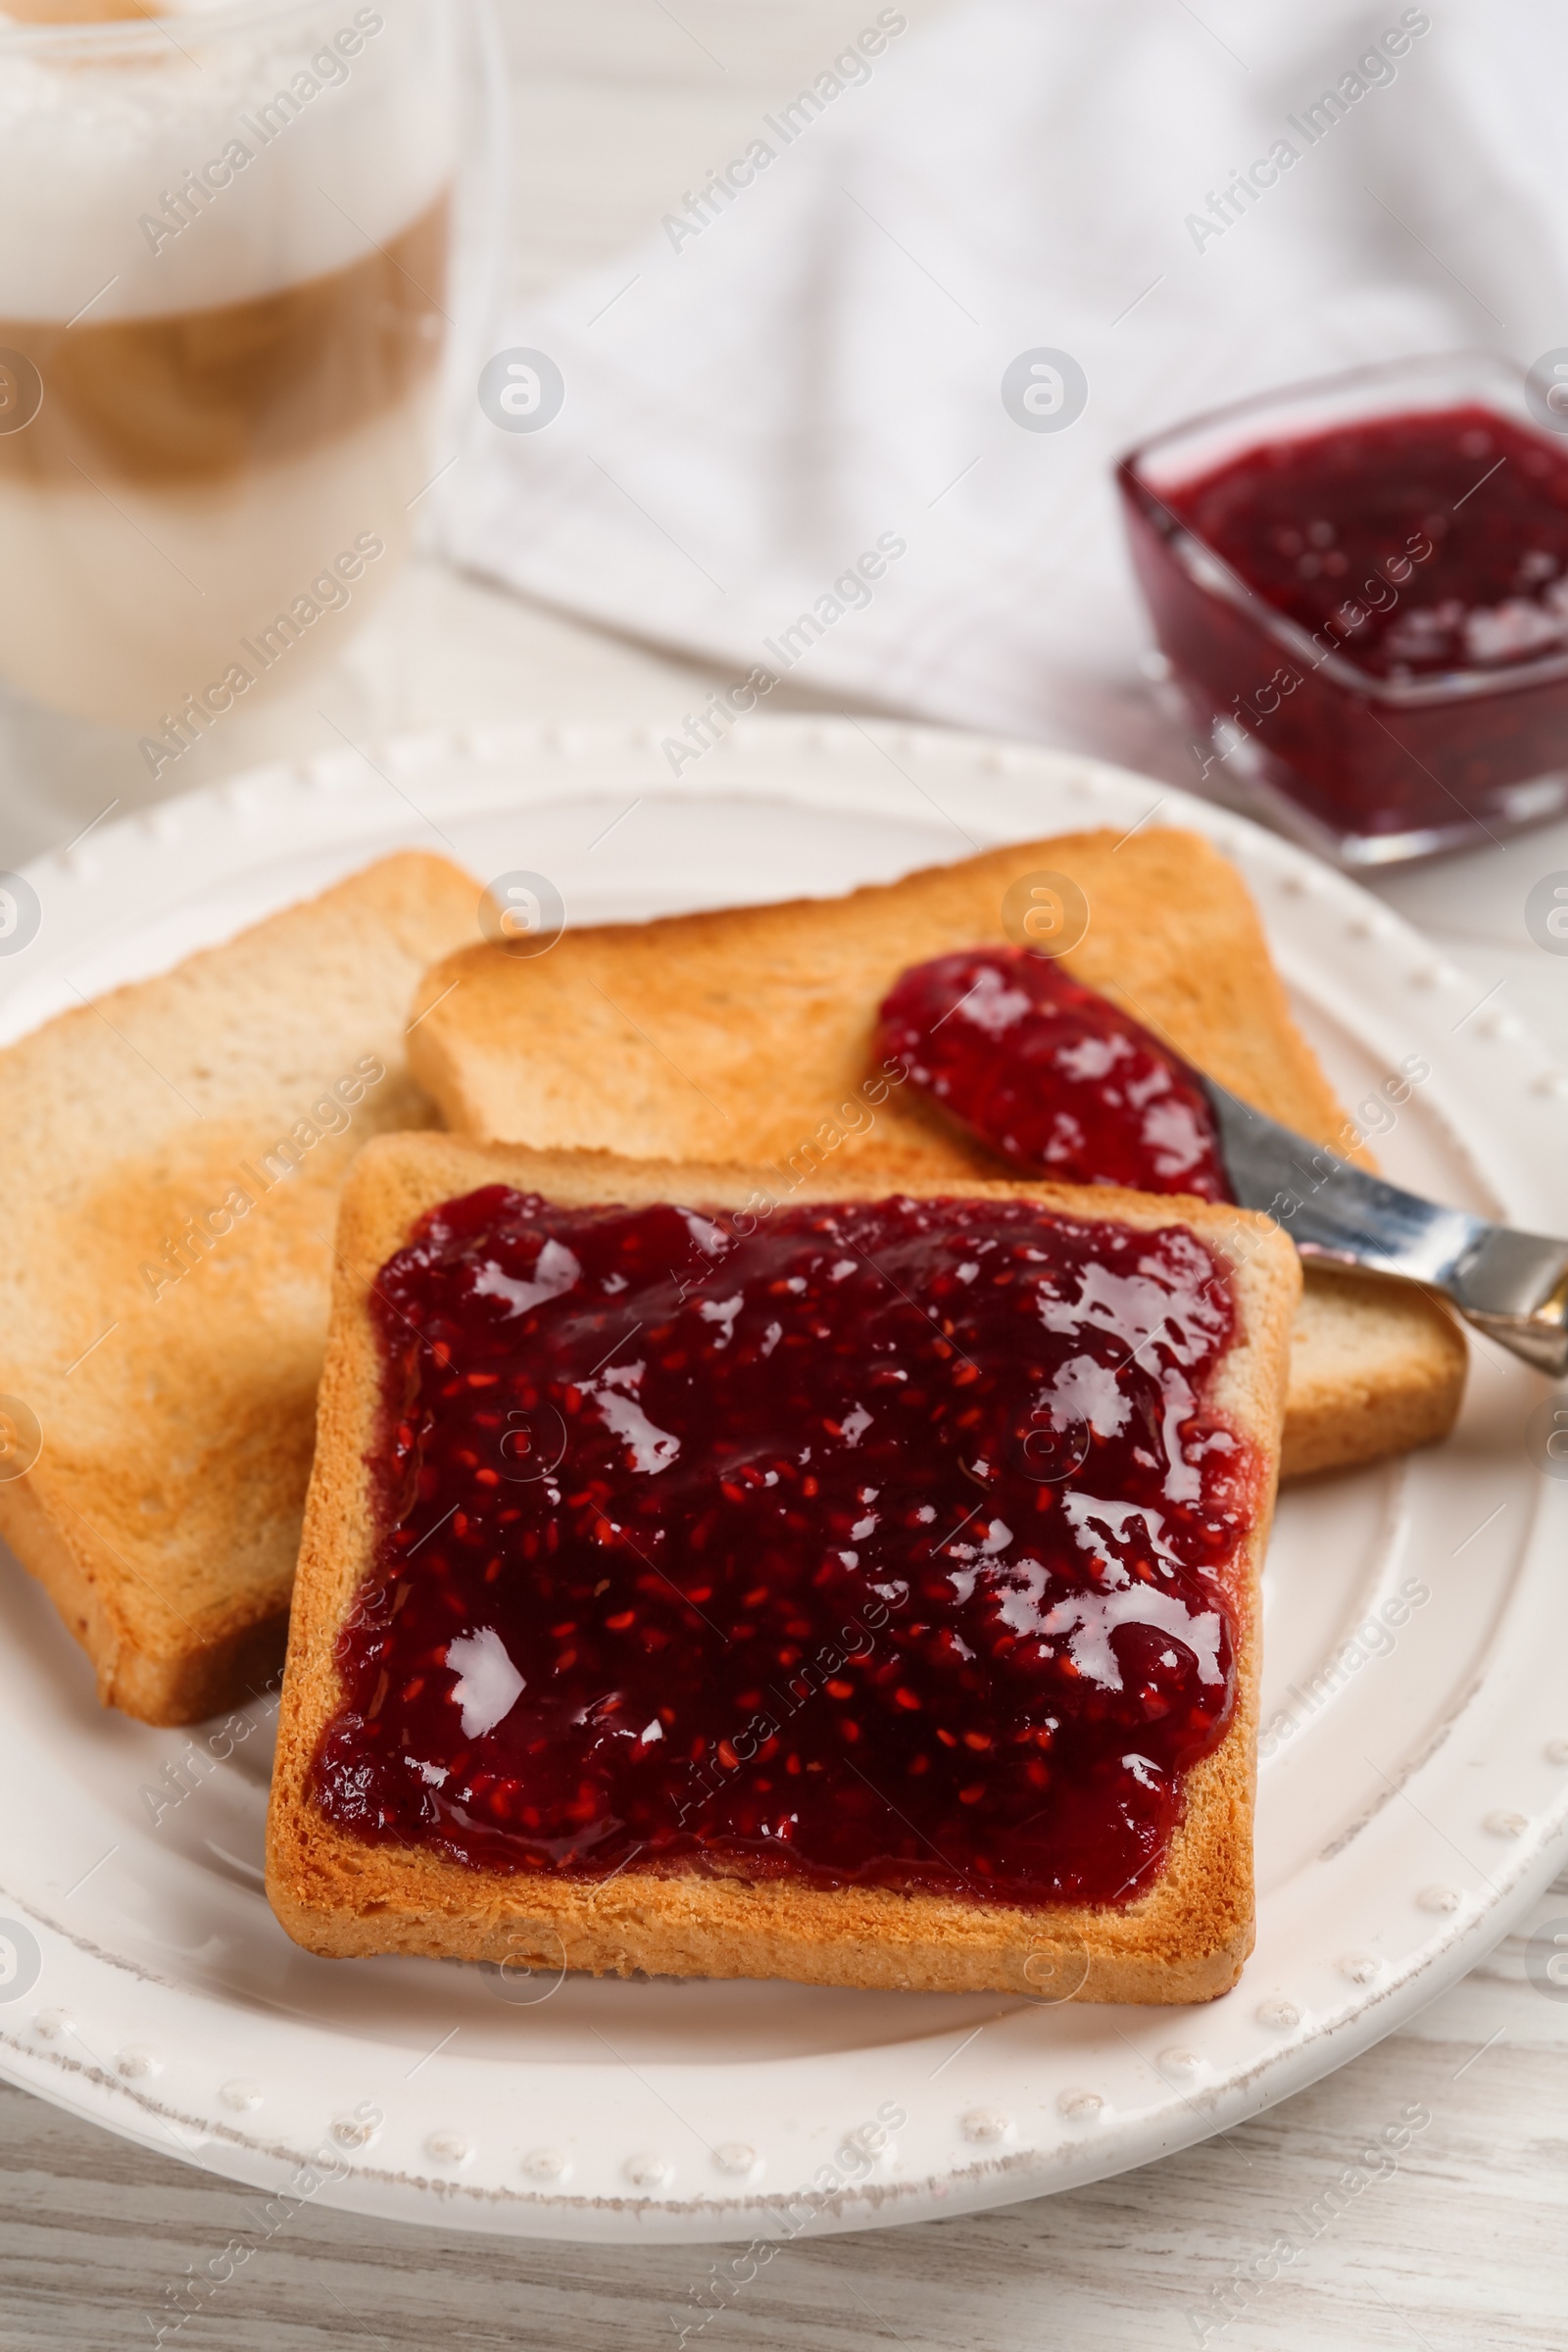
[0, 854, 479, 1724]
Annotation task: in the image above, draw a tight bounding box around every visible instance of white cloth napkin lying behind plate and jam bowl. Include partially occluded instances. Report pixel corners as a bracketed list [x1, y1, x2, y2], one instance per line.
[447, 0, 1568, 783]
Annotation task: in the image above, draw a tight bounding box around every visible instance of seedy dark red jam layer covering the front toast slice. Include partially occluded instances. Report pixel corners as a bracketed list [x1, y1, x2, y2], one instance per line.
[315, 1186, 1257, 1903]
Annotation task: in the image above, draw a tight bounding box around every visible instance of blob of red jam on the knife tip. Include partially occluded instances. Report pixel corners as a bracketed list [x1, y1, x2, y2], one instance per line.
[874, 948, 1232, 1200]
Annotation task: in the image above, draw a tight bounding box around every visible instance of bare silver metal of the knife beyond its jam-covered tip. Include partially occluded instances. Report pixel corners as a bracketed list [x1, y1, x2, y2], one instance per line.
[1201, 1077, 1568, 1378]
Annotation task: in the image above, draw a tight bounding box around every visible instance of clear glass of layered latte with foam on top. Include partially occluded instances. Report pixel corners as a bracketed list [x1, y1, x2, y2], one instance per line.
[0, 0, 496, 753]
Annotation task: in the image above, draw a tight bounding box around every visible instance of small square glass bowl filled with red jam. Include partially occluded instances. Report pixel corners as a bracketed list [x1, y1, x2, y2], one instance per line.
[1116, 353, 1568, 865]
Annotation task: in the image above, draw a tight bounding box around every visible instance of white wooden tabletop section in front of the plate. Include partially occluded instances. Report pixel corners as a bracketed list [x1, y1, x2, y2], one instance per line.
[0, 1880, 1568, 2352]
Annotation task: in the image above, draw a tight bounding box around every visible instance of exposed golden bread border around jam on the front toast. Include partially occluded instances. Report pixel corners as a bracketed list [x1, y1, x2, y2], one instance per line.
[268, 1136, 1300, 2001]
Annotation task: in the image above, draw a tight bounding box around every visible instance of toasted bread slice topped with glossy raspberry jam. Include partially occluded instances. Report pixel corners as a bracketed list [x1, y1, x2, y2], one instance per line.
[268, 1136, 1300, 2001]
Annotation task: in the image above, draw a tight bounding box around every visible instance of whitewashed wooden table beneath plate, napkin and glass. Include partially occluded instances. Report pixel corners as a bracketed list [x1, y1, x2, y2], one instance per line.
[0, 0, 1568, 2352]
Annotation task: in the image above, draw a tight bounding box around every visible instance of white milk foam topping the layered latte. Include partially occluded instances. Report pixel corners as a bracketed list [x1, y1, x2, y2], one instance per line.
[0, 0, 454, 324]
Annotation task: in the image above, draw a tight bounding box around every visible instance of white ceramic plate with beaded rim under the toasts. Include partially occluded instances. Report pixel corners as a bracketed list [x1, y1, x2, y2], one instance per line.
[0, 719, 1568, 2238]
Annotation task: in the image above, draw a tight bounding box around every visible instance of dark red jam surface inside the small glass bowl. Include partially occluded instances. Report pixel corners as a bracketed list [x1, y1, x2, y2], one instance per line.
[1168, 407, 1568, 677]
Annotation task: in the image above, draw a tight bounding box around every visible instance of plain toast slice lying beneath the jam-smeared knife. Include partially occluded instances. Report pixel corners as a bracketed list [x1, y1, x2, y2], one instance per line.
[414, 828, 1467, 1477]
